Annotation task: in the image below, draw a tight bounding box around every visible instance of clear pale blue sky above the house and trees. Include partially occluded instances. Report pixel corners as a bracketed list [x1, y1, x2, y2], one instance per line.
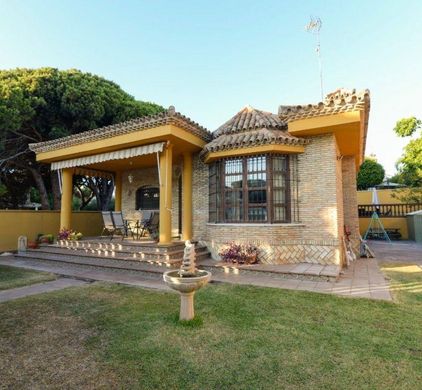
[0, 0, 422, 174]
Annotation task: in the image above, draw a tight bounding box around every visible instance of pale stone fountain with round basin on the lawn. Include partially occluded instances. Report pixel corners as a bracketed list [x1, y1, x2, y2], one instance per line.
[163, 240, 211, 320]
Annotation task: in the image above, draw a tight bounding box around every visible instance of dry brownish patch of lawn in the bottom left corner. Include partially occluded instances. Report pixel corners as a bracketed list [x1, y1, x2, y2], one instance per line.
[0, 288, 118, 389]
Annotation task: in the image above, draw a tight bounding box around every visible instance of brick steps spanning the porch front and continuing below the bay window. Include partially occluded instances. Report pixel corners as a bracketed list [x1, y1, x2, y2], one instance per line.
[15, 239, 340, 282]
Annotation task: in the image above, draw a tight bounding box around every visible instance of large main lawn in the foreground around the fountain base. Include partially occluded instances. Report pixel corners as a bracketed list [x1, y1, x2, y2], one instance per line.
[0, 265, 422, 389]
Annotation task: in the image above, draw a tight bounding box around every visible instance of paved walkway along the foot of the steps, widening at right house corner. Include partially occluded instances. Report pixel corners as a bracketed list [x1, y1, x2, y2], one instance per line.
[0, 258, 392, 300]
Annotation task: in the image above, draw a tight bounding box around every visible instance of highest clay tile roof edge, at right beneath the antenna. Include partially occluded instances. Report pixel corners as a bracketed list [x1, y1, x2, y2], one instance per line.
[278, 89, 370, 122]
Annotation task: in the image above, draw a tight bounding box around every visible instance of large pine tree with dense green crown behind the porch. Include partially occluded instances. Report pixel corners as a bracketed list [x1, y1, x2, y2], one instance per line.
[0, 68, 164, 208]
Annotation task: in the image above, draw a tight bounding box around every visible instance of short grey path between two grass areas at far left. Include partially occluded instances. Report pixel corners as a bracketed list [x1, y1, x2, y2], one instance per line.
[0, 278, 87, 303]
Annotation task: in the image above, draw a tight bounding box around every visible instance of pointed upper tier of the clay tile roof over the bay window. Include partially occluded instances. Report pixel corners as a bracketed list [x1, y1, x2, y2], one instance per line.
[214, 106, 287, 137]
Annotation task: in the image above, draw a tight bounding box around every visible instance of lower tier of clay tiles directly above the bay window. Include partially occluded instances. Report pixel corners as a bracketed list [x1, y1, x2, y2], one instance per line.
[201, 128, 308, 155]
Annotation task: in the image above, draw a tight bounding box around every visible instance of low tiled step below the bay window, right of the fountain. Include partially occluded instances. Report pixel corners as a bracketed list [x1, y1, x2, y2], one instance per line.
[197, 259, 340, 282]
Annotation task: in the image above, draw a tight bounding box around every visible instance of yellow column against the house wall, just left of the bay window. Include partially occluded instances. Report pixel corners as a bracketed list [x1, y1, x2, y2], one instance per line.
[182, 152, 192, 240]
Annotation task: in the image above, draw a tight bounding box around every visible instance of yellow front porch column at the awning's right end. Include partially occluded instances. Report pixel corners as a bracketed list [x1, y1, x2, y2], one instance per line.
[160, 145, 173, 244]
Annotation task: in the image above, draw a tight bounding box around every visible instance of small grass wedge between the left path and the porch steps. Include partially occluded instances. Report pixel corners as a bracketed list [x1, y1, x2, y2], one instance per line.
[0, 265, 56, 290]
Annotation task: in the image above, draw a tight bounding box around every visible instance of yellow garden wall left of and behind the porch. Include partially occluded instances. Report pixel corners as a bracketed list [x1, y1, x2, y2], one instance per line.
[0, 210, 103, 252]
